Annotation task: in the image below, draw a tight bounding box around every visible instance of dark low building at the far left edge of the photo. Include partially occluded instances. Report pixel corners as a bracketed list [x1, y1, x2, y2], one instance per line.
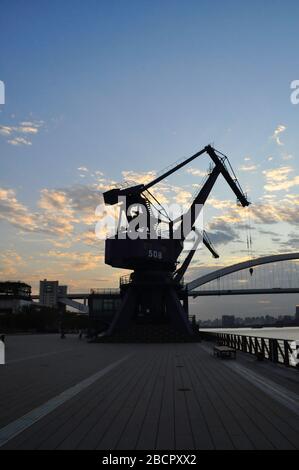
[0, 281, 32, 314]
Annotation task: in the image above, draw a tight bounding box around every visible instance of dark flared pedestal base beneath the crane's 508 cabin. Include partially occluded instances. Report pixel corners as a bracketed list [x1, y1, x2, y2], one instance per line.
[107, 271, 194, 339]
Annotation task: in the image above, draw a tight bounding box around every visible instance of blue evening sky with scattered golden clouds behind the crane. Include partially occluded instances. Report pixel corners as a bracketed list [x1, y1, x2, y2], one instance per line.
[0, 0, 299, 318]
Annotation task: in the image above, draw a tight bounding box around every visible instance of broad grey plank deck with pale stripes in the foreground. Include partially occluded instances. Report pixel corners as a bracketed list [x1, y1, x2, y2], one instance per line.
[0, 335, 299, 450]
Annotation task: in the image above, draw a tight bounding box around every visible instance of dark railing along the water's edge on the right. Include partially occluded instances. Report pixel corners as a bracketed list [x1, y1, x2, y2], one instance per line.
[200, 330, 299, 368]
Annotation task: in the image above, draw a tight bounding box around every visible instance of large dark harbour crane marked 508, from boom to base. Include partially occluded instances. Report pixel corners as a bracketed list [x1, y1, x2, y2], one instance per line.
[103, 145, 249, 337]
